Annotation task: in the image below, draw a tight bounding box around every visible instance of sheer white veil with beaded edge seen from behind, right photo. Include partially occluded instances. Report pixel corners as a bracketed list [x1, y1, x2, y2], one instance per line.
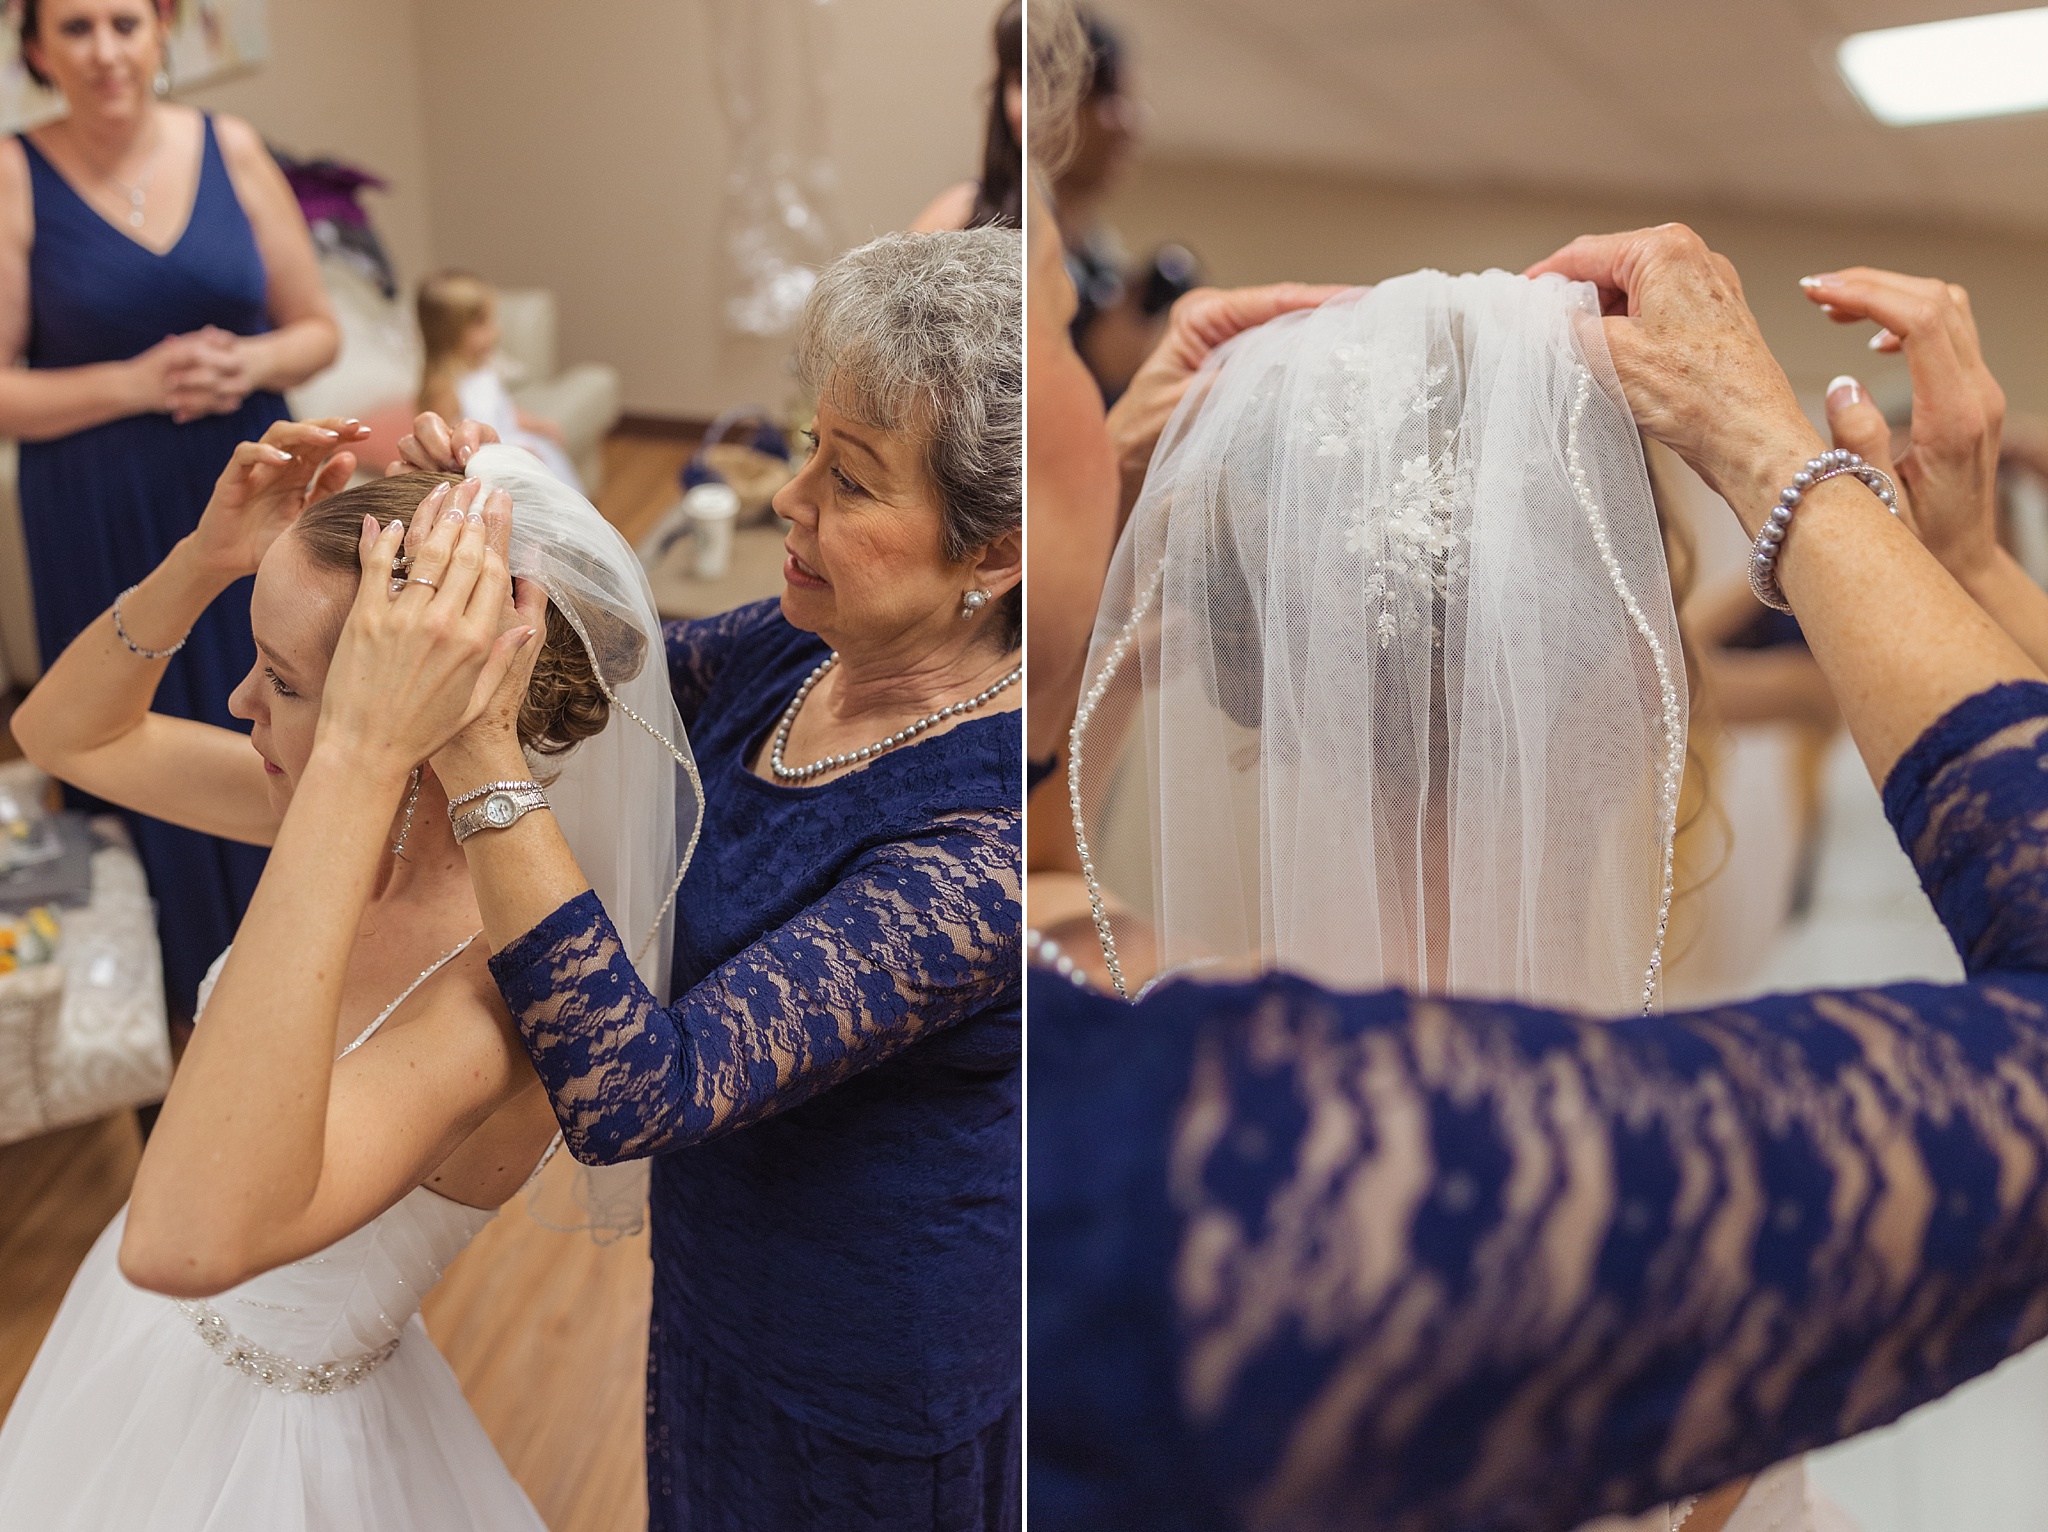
[1069, 270, 1686, 1014]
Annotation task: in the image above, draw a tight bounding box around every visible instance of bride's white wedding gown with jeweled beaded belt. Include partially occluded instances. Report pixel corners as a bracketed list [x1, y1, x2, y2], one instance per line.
[0, 954, 545, 1532]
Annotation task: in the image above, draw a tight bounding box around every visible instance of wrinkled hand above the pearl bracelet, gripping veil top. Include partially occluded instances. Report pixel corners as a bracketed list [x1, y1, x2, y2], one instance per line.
[1526, 223, 1821, 514]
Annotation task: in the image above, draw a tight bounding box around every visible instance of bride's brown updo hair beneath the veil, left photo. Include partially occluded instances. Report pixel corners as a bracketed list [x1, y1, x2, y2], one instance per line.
[293, 473, 622, 756]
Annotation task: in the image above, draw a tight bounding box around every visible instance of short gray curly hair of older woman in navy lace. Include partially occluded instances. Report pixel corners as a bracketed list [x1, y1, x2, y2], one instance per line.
[797, 227, 1024, 649]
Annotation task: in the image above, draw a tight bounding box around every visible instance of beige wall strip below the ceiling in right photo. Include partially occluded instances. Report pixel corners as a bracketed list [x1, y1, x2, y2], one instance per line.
[1110, 158, 2048, 414]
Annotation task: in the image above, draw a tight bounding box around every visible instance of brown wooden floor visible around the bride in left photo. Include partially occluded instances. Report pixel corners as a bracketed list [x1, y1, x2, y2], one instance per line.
[0, 436, 692, 1532]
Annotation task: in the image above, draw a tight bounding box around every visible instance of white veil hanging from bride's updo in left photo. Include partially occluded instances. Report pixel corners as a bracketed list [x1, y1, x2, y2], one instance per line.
[467, 444, 705, 1237]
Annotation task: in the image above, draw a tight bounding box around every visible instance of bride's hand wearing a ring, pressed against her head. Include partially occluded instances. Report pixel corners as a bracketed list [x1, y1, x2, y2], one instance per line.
[315, 479, 537, 776]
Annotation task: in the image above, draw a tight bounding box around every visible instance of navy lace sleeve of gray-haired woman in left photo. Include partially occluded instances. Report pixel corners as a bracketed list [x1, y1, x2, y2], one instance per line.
[492, 811, 1022, 1165]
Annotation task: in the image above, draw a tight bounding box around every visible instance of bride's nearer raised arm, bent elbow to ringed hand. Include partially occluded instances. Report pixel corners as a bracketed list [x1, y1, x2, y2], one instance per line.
[121, 497, 545, 1296]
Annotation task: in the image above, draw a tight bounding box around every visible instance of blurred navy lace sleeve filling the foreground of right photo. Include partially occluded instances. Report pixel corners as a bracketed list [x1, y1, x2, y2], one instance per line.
[1030, 684, 2048, 1532]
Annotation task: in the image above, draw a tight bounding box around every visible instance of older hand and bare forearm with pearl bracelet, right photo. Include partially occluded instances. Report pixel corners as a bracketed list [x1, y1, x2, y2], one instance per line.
[1530, 223, 2042, 782]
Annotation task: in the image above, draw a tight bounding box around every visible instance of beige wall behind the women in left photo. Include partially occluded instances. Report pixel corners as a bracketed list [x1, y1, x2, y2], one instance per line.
[180, 0, 995, 416]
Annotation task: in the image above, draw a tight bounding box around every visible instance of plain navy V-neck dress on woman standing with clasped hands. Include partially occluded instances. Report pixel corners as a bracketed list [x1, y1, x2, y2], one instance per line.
[20, 117, 287, 1014]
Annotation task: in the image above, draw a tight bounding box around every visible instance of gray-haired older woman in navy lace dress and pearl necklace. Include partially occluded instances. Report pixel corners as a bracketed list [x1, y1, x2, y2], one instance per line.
[395, 229, 1022, 1532]
